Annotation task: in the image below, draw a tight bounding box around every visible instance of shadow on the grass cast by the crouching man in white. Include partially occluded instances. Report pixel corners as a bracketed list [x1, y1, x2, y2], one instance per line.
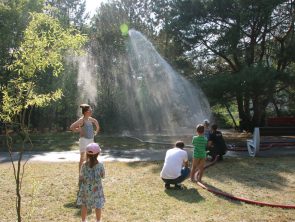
[165, 187, 205, 203]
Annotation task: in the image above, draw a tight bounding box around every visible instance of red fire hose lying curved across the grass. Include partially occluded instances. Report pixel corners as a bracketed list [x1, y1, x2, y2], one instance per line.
[197, 156, 295, 209]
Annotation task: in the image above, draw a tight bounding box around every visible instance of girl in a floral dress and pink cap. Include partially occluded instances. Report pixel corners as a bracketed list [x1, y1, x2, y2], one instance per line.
[77, 143, 105, 222]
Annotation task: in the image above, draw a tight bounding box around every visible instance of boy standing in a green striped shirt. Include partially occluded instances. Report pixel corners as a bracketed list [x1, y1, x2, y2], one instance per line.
[191, 124, 207, 182]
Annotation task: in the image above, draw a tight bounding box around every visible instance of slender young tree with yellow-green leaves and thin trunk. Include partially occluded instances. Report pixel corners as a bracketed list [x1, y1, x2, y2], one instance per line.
[0, 13, 86, 222]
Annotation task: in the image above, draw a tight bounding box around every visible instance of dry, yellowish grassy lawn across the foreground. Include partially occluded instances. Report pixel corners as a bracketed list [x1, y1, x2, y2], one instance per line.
[0, 157, 295, 222]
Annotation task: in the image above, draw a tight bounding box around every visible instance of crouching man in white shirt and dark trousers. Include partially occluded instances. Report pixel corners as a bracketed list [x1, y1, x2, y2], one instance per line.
[160, 141, 190, 189]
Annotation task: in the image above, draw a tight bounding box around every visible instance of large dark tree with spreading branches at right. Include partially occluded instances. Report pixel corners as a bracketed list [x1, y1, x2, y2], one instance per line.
[166, 0, 294, 130]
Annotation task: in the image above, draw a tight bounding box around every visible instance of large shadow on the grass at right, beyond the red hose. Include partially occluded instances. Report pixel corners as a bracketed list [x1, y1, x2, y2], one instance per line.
[205, 156, 295, 190]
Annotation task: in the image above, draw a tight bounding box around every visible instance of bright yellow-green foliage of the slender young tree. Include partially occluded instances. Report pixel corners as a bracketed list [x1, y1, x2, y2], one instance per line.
[1, 13, 85, 122]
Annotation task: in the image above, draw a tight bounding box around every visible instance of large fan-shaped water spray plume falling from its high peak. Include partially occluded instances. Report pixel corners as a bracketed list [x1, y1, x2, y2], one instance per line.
[125, 30, 211, 135]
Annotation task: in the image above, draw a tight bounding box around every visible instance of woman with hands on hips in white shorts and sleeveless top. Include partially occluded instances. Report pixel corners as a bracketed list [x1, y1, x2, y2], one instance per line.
[70, 104, 99, 173]
